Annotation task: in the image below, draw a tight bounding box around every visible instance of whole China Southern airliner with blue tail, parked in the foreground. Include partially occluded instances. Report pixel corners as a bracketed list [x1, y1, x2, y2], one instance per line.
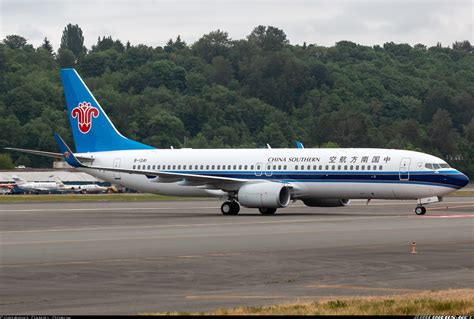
[4, 68, 469, 215]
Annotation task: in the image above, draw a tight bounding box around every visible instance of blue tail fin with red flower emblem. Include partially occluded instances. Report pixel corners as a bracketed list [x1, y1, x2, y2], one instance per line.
[61, 69, 153, 153]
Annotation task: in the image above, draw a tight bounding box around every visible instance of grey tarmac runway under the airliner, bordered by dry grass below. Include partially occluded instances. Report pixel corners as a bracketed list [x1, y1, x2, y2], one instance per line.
[0, 197, 474, 314]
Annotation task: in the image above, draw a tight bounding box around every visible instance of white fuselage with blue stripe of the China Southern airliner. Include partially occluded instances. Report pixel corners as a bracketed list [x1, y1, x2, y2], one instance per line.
[76, 148, 464, 199]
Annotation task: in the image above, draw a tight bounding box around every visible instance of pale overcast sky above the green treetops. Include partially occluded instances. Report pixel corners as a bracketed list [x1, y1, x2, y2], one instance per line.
[0, 0, 474, 49]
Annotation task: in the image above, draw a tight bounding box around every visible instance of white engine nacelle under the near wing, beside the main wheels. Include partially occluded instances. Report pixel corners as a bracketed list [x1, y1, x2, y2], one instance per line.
[237, 182, 290, 208]
